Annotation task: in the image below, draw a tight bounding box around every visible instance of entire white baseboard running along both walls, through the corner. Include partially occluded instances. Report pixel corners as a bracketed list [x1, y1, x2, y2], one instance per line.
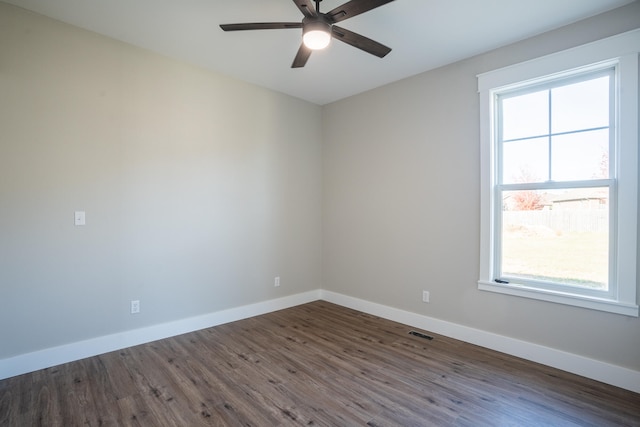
[0, 290, 640, 393]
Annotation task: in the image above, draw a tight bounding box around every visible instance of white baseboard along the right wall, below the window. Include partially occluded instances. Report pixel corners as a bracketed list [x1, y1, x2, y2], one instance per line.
[320, 290, 640, 393]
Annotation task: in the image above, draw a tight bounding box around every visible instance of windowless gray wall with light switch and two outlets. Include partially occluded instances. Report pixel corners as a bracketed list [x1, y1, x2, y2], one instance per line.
[0, 3, 322, 359]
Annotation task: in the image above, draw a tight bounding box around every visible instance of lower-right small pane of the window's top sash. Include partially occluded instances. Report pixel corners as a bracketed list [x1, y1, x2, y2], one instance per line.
[551, 129, 609, 181]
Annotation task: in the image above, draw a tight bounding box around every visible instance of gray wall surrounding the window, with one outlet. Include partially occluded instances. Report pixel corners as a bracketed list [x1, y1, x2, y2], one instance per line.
[323, 2, 640, 370]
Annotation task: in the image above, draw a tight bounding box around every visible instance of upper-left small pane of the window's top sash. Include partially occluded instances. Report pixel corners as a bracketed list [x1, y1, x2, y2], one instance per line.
[502, 90, 549, 140]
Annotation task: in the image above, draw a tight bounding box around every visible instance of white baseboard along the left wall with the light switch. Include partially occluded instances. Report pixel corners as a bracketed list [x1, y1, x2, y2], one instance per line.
[0, 290, 320, 380]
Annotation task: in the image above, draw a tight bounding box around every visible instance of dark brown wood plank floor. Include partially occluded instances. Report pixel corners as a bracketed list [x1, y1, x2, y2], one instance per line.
[0, 301, 640, 427]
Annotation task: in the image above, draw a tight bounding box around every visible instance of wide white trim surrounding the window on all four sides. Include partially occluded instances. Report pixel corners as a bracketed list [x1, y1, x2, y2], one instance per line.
[478, 30, 640, 317]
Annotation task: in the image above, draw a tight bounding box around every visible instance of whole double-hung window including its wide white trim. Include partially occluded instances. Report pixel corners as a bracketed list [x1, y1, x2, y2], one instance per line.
[478, 31, 640, 316]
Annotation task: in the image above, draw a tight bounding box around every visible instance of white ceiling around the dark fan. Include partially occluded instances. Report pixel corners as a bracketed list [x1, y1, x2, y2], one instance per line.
[1, 0, 633, 105]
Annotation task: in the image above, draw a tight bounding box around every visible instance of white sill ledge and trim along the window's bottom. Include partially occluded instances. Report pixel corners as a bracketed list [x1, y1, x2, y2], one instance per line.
[478, 280, 638, 317]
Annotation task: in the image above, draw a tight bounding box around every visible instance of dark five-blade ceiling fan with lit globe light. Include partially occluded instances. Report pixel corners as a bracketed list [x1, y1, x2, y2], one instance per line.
[220, 0, 394, 68]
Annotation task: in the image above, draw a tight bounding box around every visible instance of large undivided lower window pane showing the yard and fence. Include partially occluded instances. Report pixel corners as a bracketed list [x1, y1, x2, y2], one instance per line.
[500, 187, 609, 291]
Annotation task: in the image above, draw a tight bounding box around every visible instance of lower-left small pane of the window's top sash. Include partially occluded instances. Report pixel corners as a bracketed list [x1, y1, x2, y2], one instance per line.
[502, 138, 549, 184]
